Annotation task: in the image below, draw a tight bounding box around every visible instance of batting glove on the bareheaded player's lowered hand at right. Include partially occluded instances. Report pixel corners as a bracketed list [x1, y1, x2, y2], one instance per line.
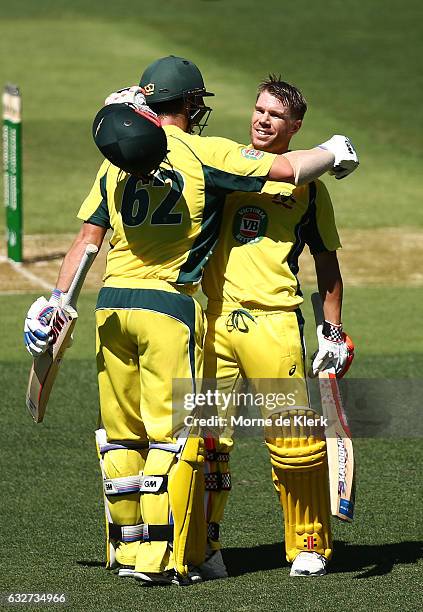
[309, 321, 354, 378]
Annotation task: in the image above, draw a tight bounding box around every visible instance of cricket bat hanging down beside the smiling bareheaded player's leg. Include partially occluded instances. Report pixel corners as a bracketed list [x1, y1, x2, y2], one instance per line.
[311, 293, 355, 522]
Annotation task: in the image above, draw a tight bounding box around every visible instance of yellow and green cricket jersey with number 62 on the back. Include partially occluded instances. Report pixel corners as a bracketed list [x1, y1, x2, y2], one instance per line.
[78, 126, 276, 288]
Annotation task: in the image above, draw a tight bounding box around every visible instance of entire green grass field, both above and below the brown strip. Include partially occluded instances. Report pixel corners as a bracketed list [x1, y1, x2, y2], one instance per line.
[0, 0, 423, 612]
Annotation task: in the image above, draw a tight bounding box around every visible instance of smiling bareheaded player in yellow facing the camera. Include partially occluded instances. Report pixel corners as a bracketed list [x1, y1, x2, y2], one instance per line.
[202, 76, 356, 575]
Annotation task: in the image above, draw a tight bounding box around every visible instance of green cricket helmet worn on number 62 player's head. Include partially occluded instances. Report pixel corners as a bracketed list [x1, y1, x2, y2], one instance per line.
[140, 55, 214, 132]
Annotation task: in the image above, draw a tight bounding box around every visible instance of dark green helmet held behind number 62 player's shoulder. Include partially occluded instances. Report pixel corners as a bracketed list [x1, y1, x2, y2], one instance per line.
[93, 104, 167, 176]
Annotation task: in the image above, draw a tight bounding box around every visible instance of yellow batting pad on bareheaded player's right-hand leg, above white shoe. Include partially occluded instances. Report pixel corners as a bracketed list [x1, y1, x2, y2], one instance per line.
[266, 410, 332, 562]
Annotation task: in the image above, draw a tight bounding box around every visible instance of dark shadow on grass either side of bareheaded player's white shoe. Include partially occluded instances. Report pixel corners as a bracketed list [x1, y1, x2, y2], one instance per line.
[222, 540, 423, 578]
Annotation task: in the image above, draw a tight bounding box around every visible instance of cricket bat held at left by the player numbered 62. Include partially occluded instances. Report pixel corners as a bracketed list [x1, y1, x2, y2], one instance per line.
[26, 244, 98, 423]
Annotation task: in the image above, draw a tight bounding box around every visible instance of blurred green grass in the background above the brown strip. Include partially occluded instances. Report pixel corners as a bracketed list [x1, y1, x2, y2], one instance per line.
[0, 0, 423, 233]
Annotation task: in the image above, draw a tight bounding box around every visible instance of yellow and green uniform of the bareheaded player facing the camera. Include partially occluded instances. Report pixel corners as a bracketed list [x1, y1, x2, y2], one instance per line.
[202, 181, 340, 561]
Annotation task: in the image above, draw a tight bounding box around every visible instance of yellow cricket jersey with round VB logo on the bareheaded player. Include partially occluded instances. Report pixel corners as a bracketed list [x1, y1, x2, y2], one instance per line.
[202, 181, 341, 314]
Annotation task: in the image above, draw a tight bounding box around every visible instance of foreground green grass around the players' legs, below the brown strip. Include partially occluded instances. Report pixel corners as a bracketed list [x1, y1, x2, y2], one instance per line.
[0, 289, 423, 612]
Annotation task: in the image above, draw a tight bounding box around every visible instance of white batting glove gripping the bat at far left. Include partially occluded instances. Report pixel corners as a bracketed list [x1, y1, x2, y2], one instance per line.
[24, 289, 65, 357]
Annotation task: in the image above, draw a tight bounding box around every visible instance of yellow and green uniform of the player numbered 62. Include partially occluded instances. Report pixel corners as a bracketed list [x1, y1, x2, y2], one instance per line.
[78, 126, 275, 574]
